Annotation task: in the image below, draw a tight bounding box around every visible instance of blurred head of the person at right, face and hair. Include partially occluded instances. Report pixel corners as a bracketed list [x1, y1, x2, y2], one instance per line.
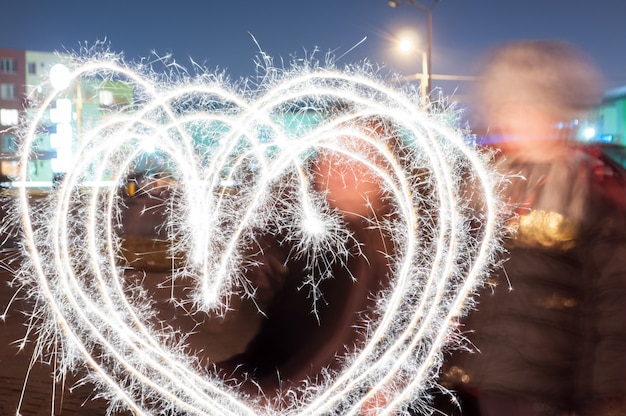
[474, 40, 602, 158]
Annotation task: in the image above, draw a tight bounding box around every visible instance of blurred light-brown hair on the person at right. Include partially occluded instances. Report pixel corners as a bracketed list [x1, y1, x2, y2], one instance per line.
[474, 40, 602, 130]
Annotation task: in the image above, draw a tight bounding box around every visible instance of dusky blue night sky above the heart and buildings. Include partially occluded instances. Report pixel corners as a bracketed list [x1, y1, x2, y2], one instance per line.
[0, 0, 626, 100]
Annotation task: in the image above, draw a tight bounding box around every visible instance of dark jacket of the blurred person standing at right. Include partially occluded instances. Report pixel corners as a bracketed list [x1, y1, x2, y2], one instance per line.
[442, 150, 626, 410]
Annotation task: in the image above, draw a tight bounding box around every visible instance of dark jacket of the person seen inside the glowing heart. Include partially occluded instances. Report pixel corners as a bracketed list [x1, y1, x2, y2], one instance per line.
[214, 216, 389, 398]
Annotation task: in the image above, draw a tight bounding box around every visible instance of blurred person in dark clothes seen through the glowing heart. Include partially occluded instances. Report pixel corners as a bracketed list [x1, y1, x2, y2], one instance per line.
[218, 120, 393, 409]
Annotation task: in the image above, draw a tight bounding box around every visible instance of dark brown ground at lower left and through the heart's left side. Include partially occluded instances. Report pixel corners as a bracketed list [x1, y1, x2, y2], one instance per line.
[0, 191, 260, 416]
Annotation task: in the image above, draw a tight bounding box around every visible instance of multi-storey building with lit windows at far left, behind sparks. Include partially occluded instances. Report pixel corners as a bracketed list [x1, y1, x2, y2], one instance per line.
[0, 49, 133, 187]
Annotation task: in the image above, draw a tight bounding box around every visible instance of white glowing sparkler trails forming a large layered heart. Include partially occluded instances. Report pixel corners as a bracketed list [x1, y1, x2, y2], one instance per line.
[9, 55, 500, 415]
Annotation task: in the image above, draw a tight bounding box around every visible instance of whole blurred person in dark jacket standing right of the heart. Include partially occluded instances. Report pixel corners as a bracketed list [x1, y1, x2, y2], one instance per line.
[440, 41, 626, 416]
